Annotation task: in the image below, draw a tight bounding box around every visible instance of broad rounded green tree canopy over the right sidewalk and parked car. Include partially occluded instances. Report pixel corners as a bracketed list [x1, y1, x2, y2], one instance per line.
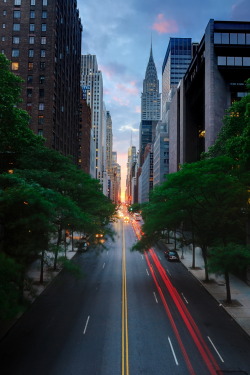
[139, 157, 247, 253]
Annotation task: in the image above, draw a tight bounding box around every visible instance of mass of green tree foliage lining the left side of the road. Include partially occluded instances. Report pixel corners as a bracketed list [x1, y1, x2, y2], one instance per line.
[0, 54, 115, 316]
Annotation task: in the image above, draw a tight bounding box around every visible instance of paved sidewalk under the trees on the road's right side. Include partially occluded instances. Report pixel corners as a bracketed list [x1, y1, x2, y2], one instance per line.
[161, 243, 250, 335]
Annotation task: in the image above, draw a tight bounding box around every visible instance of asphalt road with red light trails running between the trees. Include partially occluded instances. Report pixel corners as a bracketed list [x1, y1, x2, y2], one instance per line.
[0, 221, 250, 375]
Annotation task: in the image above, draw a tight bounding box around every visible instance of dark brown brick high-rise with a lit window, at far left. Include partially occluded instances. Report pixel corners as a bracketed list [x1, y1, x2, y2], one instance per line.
[0, 0, 82, 163]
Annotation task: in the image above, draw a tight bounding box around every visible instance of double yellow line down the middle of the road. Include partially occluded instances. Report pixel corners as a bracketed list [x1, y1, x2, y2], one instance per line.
[122, 226, 129, 375]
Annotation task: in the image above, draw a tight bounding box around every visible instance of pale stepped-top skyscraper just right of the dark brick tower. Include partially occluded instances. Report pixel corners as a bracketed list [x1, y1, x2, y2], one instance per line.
[81, 55, 104, 180]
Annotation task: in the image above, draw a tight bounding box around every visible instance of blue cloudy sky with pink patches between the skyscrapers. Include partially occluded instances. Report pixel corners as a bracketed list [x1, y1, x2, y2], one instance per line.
[78, 0, 250, 200]
